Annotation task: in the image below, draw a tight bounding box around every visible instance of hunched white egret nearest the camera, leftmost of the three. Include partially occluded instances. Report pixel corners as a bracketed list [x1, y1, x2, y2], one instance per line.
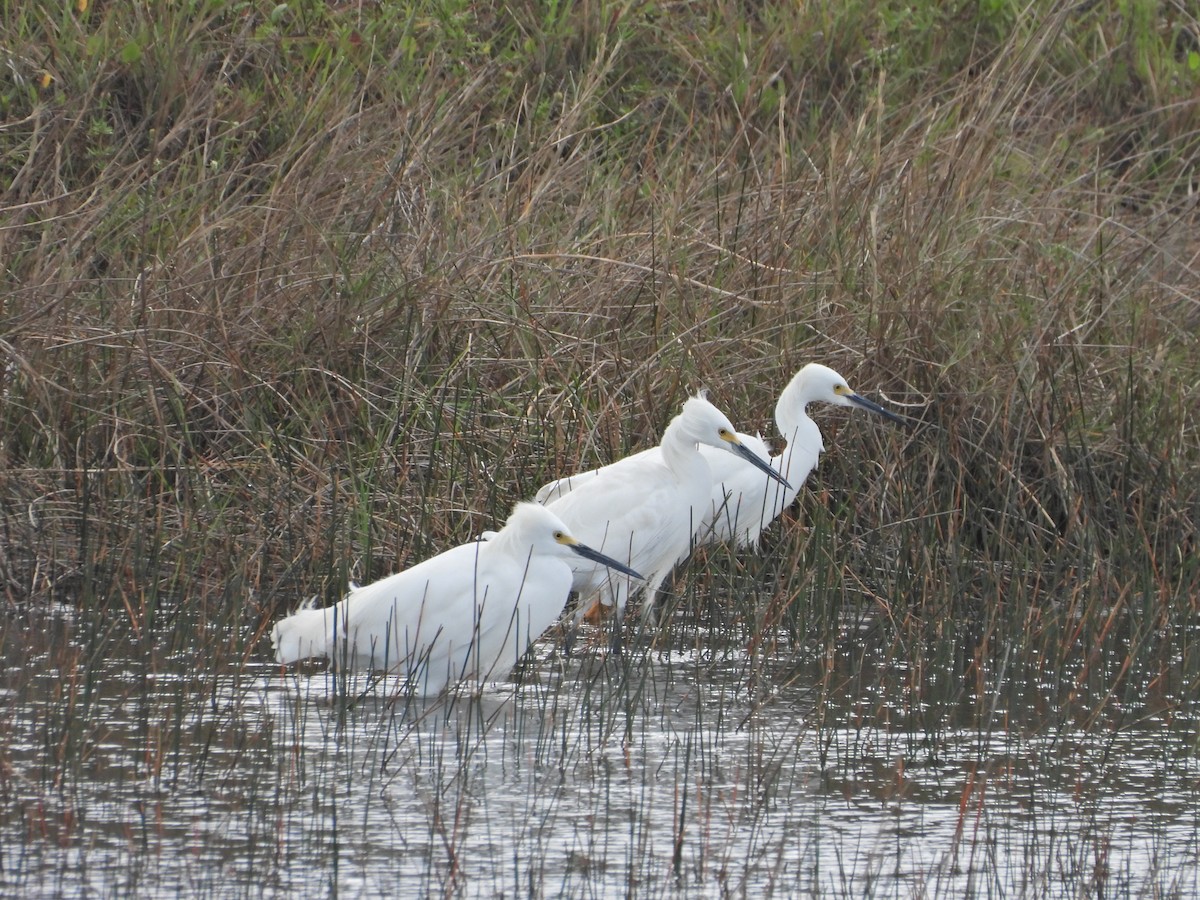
[271, 503, 642, 696]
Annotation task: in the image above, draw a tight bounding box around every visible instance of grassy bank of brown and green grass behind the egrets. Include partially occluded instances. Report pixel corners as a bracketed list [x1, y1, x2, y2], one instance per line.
[0, 0, 1200, 719]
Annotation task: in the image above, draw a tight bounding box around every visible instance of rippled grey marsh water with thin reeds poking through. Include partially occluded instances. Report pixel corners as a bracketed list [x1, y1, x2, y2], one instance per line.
[0, 611, 1200, 898]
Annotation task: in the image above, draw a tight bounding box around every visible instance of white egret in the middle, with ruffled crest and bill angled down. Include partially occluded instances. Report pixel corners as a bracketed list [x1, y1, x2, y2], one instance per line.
[547, 396, 786, 628]
